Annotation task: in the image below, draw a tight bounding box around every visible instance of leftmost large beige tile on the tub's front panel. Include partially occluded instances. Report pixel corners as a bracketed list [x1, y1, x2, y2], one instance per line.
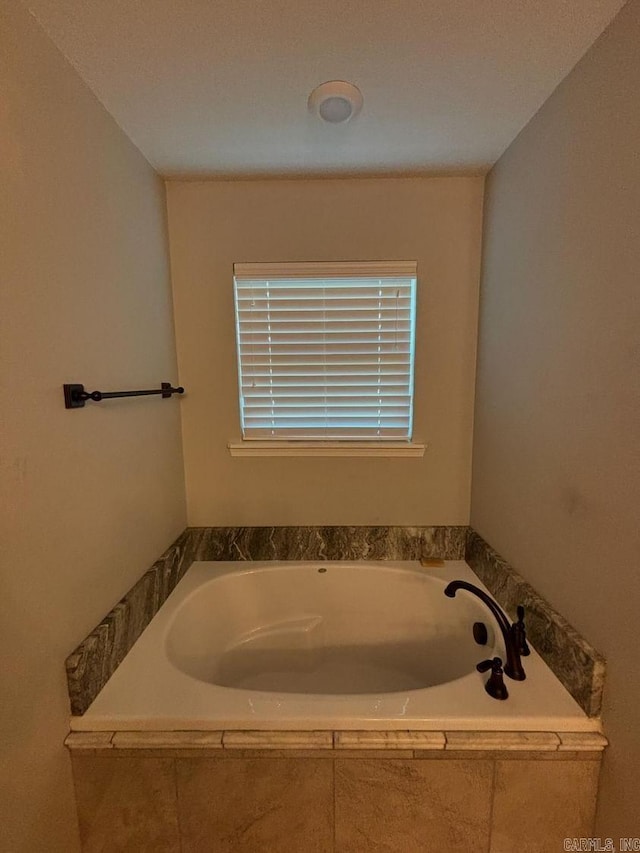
[72, 750, 180, 853]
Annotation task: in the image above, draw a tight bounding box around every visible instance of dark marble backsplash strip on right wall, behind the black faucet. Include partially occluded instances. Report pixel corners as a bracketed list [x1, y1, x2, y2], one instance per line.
[465, 528, 605, 717]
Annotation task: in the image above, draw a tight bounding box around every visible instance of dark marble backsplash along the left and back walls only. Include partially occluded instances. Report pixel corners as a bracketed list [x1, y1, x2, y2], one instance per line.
[65, 526, 467, 716]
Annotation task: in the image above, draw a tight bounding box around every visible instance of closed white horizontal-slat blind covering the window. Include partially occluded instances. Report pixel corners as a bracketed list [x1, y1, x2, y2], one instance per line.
[234, 262, 416, 441]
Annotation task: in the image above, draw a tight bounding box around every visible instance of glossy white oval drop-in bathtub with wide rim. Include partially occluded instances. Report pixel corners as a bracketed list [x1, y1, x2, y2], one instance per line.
[71, 561, 600, 732]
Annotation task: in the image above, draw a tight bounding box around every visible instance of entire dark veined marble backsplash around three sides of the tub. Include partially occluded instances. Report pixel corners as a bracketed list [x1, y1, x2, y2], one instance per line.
[66, 526, 604, 717]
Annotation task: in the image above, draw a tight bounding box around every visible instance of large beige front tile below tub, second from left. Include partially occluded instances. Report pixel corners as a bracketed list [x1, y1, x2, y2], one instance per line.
[176, 757, 333, 853]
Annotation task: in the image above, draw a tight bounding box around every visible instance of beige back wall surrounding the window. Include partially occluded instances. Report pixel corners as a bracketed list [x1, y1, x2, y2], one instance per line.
[167, 178, 483, 525]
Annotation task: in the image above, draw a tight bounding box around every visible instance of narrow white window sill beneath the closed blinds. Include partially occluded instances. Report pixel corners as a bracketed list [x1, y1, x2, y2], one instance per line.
[227, 441, 427, 457]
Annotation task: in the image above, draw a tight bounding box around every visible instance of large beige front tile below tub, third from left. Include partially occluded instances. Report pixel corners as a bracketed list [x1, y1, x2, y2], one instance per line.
[335, 758, 493, 853]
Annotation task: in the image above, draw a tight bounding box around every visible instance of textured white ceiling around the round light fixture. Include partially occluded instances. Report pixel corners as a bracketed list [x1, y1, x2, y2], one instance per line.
[24, 0, 624, 177]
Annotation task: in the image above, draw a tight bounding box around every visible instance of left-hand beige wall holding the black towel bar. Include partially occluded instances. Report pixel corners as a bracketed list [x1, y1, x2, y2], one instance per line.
[0, 2, 185, 853]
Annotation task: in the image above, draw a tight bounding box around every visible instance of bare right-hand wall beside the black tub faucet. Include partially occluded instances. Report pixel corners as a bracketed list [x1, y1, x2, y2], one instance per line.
[471, 0, 640, 837]
